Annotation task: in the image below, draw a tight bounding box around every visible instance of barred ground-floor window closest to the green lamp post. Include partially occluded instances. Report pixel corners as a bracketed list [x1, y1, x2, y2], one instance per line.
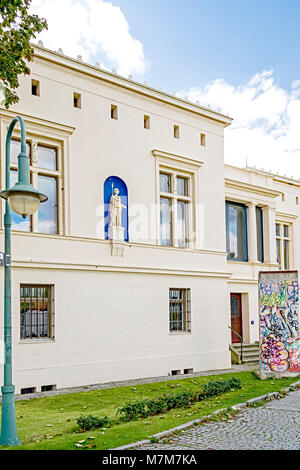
[20, 284, 54, 339]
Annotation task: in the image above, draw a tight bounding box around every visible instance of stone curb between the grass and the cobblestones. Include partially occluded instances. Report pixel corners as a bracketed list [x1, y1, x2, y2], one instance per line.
[109, 380, 300, 450]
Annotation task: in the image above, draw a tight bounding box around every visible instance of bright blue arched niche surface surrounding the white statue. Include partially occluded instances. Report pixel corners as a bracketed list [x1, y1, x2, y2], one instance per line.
[104, 176, 129, 242]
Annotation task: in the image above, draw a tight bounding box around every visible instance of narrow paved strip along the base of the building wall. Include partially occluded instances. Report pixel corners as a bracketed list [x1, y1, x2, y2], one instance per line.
[11, 364, 258, 403]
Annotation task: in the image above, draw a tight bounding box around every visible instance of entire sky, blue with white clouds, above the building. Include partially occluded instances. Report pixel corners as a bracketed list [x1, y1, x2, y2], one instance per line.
[32, 0, 300, 178]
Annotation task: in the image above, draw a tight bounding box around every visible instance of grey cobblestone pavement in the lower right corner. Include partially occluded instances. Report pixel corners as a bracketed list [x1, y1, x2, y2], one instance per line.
[140, 390, 300, 450]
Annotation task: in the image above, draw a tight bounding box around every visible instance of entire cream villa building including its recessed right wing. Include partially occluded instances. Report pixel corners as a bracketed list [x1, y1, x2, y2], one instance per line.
[0, 46, 300, 393]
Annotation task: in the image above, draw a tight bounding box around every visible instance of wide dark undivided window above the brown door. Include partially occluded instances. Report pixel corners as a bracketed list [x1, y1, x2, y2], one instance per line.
[226, 201, 248, 261]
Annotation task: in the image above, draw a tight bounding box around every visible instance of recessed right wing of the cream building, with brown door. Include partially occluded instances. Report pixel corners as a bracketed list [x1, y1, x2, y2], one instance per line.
[225, 165, 300, 350]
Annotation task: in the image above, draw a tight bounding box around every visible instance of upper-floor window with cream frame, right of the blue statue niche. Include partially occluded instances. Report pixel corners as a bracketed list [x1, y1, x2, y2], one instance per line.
[159, 171, 192, 248]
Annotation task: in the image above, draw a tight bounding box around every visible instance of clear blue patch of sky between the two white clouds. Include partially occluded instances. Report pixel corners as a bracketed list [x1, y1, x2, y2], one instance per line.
[111, 0, 300, 89]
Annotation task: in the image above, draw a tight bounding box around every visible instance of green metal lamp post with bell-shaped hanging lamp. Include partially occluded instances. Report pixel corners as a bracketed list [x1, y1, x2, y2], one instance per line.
[0, 116, 48, 446]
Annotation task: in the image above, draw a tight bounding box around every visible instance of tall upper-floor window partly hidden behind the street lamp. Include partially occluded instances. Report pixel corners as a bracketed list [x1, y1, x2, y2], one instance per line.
[10, 140, 61, 234]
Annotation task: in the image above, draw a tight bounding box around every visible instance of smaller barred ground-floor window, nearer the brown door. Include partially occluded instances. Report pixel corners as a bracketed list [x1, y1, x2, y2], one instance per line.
[169, 289, 191, 331]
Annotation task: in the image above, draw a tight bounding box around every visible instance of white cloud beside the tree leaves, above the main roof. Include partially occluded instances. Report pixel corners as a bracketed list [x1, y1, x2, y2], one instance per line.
[31, 0, 146, 76]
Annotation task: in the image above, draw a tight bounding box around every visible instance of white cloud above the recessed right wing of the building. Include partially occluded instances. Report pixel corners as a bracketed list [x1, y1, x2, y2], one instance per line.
[180, 70, 300, 178]
